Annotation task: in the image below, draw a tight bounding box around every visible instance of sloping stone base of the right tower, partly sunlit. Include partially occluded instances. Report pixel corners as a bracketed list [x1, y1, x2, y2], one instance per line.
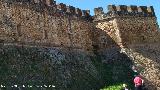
[123, 44, 160, 90]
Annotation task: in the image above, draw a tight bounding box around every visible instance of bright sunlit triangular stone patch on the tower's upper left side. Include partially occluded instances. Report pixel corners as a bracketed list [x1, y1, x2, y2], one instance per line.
[94, 18, 122, 48]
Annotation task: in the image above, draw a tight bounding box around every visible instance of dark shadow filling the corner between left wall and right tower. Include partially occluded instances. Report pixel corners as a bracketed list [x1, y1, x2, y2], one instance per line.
[90, 29, 158, 90]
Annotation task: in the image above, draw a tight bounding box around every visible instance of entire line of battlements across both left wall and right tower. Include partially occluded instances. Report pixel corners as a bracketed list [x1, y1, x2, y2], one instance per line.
[4, 0, 155, 20]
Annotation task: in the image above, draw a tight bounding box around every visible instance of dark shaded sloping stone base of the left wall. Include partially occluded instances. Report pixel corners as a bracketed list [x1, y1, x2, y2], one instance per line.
[0, 45, 100, 90]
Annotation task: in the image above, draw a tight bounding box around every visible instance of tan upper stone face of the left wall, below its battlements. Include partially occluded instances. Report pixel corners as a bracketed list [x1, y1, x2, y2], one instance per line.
[0, 2, 92, 49]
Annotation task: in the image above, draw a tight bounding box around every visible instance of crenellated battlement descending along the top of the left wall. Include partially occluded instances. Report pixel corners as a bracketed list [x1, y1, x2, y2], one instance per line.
[4, 0, 91, 18]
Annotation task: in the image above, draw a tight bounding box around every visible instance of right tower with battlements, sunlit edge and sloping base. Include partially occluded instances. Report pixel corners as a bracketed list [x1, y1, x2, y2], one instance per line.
[94, 5, 160, 90]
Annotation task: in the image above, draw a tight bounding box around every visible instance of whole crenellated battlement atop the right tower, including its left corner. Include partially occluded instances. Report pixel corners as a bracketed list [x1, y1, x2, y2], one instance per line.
[94, 5, 155, 20]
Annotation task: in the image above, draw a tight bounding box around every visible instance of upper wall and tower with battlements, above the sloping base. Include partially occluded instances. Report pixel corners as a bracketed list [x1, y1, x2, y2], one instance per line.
[0, 0, 159, 51]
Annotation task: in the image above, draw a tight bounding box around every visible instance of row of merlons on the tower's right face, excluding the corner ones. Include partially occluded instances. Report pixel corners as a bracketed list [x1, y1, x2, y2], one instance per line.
[108, 5, 155, 17]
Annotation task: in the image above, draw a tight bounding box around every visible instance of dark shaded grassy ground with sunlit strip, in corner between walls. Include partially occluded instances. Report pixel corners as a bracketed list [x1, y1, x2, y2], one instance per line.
[92, 53, 134, 90]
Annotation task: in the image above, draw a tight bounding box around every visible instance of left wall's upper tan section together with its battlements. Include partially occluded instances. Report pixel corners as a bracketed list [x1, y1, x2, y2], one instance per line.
[0, 0, 92, 50]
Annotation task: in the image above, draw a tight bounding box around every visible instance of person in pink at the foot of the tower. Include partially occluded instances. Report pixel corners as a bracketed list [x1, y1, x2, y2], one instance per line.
[134, 75, 144, 90]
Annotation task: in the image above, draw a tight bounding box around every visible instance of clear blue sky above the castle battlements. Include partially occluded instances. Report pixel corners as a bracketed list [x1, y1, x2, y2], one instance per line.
[56, 0, 160, 25]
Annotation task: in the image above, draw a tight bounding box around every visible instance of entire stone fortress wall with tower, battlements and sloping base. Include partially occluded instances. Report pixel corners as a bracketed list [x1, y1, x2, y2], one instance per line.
[0, 0, 160, 90]
